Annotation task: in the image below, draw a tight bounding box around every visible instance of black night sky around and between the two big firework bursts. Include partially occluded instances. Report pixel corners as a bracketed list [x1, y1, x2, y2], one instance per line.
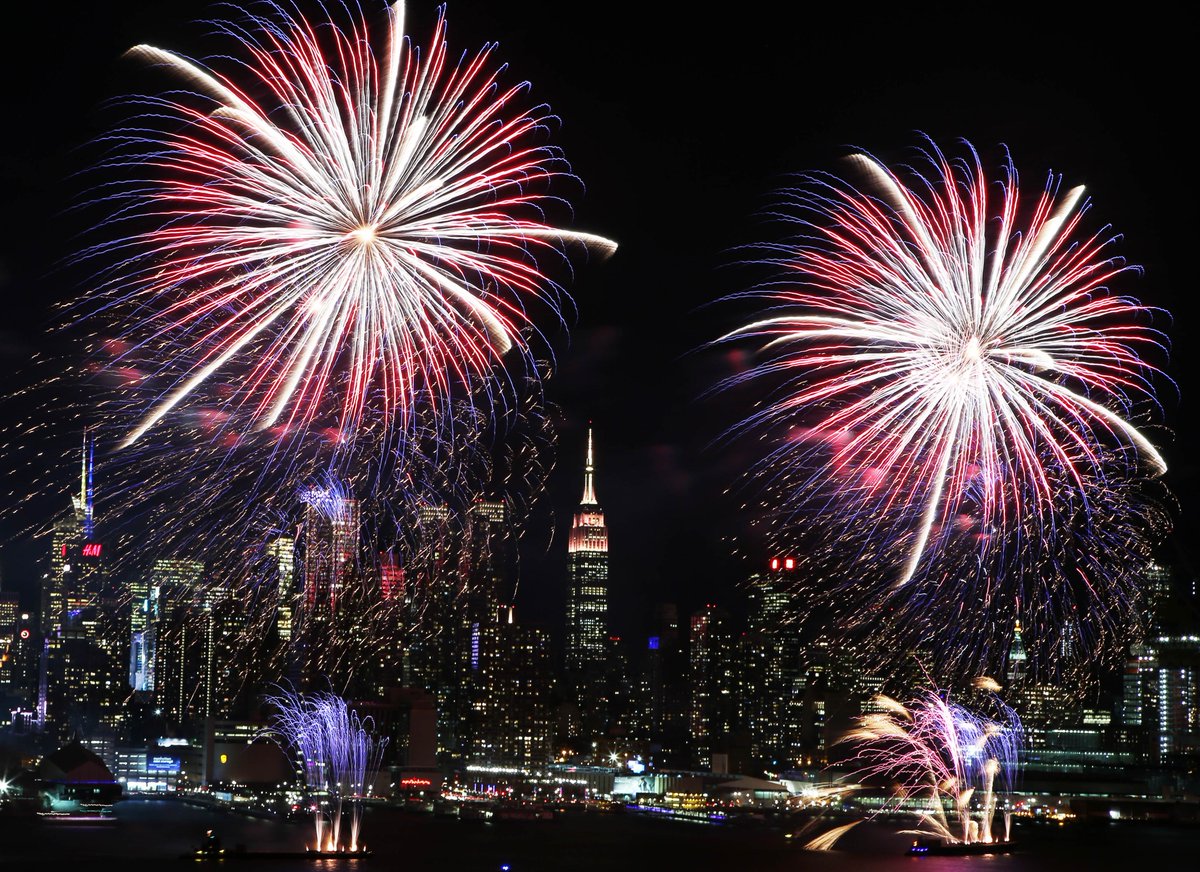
[0, 0, 1200, 633]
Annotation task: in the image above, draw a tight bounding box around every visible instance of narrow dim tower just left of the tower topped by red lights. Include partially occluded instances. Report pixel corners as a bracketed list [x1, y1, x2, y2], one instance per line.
[688, 603, 736, 766]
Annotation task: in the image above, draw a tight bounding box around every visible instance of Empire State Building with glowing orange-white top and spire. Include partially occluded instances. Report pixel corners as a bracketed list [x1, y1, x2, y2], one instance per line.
[566, 427, 608, 673]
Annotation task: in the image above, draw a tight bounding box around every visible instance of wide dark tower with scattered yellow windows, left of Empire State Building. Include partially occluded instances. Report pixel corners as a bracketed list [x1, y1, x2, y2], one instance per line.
[468, 607, 553, 768]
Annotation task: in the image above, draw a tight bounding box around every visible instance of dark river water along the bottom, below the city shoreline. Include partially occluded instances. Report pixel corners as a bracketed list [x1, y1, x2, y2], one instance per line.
[0, 800, 1200, 872]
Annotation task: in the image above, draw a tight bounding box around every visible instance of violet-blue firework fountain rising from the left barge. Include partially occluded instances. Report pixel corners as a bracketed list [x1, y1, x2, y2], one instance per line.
[269, 691, 386, 854]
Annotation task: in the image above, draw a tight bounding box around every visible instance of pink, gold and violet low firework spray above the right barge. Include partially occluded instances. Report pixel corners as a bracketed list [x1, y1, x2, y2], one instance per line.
[841, 679, 1021, 843]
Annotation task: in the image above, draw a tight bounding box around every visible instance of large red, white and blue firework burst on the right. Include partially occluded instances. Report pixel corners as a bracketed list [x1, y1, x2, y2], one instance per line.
[722, 146, 1165, 676]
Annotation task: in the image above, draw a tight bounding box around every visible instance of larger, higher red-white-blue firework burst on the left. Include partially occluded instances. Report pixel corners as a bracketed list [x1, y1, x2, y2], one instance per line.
[88, 4, 614, 447]
